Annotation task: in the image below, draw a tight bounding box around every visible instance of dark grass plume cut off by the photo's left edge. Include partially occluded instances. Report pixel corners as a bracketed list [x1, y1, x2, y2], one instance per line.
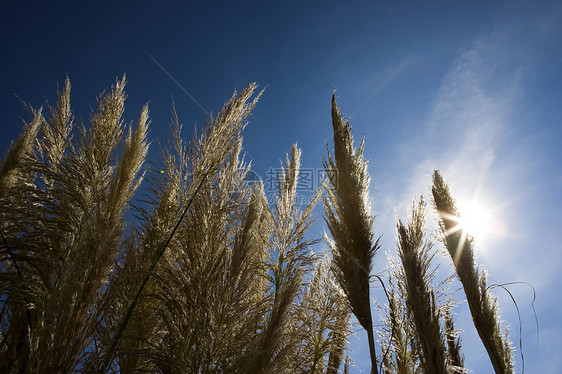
[0, 95, 44, 372]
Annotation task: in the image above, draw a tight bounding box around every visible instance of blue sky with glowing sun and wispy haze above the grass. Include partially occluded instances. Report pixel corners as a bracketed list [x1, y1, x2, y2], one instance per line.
[0, 0, 562, 373]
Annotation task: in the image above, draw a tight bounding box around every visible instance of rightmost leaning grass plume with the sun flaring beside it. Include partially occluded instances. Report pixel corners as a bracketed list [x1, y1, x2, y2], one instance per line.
[432, 170, 513, 374]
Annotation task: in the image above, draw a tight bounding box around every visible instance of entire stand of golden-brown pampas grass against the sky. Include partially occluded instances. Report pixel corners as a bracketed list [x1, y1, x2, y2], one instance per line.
[0, 76, 512, 374]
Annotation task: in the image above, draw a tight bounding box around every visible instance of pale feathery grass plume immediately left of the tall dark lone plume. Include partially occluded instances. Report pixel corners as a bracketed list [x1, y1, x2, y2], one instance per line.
[247, 144, 319, 373]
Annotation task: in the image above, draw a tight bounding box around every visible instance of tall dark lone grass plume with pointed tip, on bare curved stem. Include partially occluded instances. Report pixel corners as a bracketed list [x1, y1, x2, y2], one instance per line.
[324, 95, 378, 373]
